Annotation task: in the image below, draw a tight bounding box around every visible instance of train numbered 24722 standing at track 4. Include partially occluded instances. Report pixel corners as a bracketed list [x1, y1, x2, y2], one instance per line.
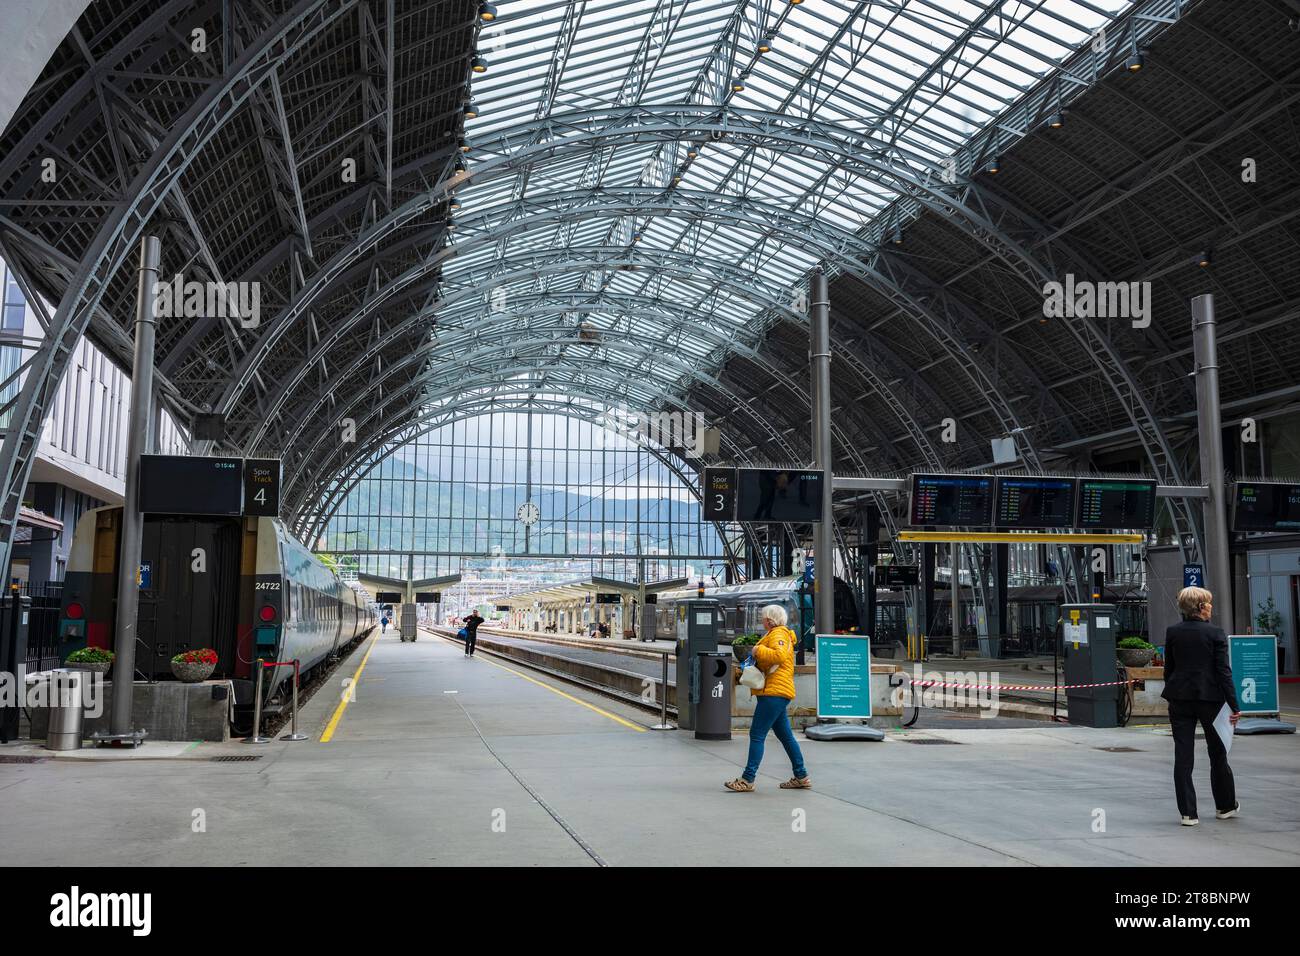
[59, 506, 378, 728]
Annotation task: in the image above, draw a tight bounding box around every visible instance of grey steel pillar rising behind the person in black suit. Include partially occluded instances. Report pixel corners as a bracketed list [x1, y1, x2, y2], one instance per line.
[1192, 294, 1232, 631]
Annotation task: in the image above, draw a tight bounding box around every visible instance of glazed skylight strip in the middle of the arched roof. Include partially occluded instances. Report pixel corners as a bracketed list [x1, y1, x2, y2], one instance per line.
[434, 0, 1131, 405]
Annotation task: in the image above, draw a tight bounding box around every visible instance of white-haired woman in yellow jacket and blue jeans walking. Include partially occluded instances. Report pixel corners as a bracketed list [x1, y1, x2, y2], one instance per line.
[723, 604, 813, 793]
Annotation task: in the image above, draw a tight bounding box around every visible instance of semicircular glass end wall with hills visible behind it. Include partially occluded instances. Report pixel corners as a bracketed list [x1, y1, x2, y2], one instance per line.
[317, 411, 738, 580]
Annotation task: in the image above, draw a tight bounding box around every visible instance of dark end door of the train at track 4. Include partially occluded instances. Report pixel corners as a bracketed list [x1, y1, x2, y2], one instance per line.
[135, 515, 242, 679]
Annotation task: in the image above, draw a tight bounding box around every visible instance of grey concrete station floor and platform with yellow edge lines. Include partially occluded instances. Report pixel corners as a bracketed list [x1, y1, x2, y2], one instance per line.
[0, 633, 1300, 866]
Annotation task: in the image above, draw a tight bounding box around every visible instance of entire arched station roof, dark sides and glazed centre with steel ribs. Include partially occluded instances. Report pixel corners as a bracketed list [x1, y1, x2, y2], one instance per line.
[0, 0, 1300, 561]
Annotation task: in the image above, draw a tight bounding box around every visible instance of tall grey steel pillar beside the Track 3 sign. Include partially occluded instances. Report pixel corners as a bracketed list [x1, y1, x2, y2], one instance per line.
[809, 269, 835, 633]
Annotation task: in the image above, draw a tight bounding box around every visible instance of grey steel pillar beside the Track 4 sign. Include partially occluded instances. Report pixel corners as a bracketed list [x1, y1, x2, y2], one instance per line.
[109, 235, 163, 736]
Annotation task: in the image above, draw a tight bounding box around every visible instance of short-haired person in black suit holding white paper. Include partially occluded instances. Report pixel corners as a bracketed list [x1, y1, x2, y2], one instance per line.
[1161, 588, 1242, 826]
